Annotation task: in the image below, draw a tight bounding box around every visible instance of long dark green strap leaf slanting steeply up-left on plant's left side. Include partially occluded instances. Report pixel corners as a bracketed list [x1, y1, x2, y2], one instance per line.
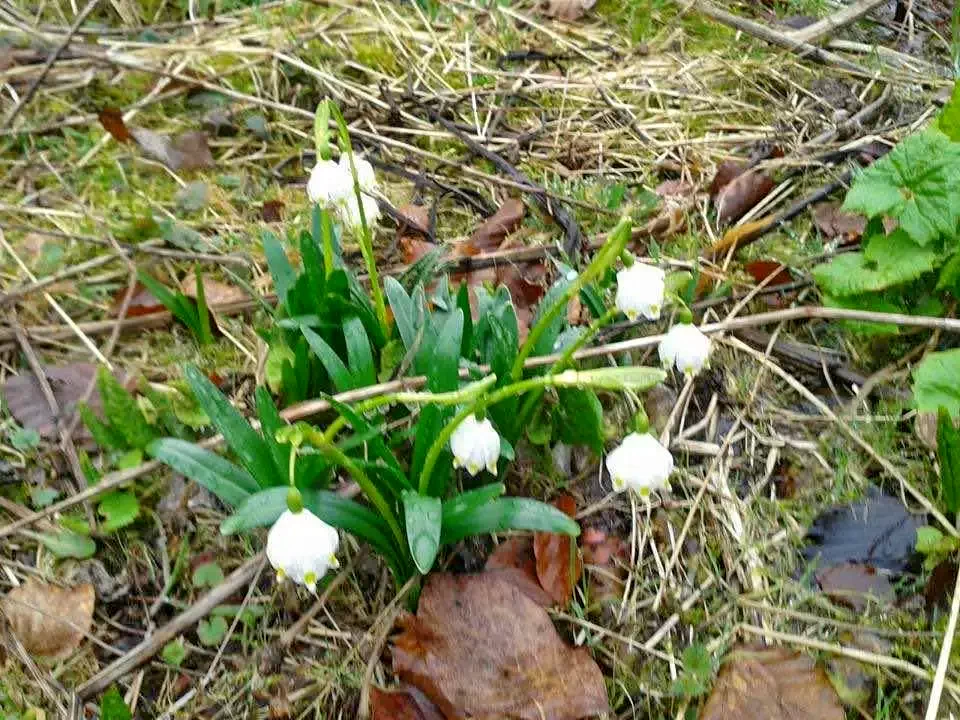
[184, 365, 286, 487]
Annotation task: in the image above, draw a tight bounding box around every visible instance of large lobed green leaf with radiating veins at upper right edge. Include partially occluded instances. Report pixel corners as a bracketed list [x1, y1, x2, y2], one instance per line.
[835, 130, 960, 248]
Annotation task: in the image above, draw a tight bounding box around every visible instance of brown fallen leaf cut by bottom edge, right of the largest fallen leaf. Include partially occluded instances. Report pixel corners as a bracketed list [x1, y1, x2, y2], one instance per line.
[700, 646, 846, 720]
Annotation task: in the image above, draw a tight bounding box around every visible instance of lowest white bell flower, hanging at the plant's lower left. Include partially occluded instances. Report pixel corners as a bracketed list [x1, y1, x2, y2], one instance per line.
[267, 510, 340, 592]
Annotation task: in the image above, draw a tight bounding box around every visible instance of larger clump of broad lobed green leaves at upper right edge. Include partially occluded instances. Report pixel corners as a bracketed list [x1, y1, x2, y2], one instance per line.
[813, 91, 960, 334]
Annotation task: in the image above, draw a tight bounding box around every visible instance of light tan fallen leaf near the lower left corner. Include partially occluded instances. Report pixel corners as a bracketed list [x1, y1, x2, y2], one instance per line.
[0, 577, 94, 660]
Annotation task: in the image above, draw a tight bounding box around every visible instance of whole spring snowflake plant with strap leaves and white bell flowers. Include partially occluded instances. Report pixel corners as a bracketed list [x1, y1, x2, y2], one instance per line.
[148, 97, 720, 588]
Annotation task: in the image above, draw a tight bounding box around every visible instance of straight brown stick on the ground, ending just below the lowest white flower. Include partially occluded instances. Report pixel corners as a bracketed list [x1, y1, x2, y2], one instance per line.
[76, 552, 266, 700]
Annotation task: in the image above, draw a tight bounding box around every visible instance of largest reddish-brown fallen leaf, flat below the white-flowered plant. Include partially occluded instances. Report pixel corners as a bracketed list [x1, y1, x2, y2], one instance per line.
[393, 573, 610, 720]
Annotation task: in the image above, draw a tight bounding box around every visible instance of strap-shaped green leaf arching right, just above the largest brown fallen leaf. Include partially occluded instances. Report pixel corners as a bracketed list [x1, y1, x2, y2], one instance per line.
[440, 497, 580, 545]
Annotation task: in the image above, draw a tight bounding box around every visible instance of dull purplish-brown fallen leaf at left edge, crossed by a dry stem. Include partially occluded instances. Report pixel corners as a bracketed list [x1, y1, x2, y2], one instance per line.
[3, 363, 123, 440]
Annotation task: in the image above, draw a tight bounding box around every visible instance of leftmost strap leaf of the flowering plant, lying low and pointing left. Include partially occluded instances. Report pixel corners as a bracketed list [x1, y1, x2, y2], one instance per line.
[147, 438, 258, 507]
